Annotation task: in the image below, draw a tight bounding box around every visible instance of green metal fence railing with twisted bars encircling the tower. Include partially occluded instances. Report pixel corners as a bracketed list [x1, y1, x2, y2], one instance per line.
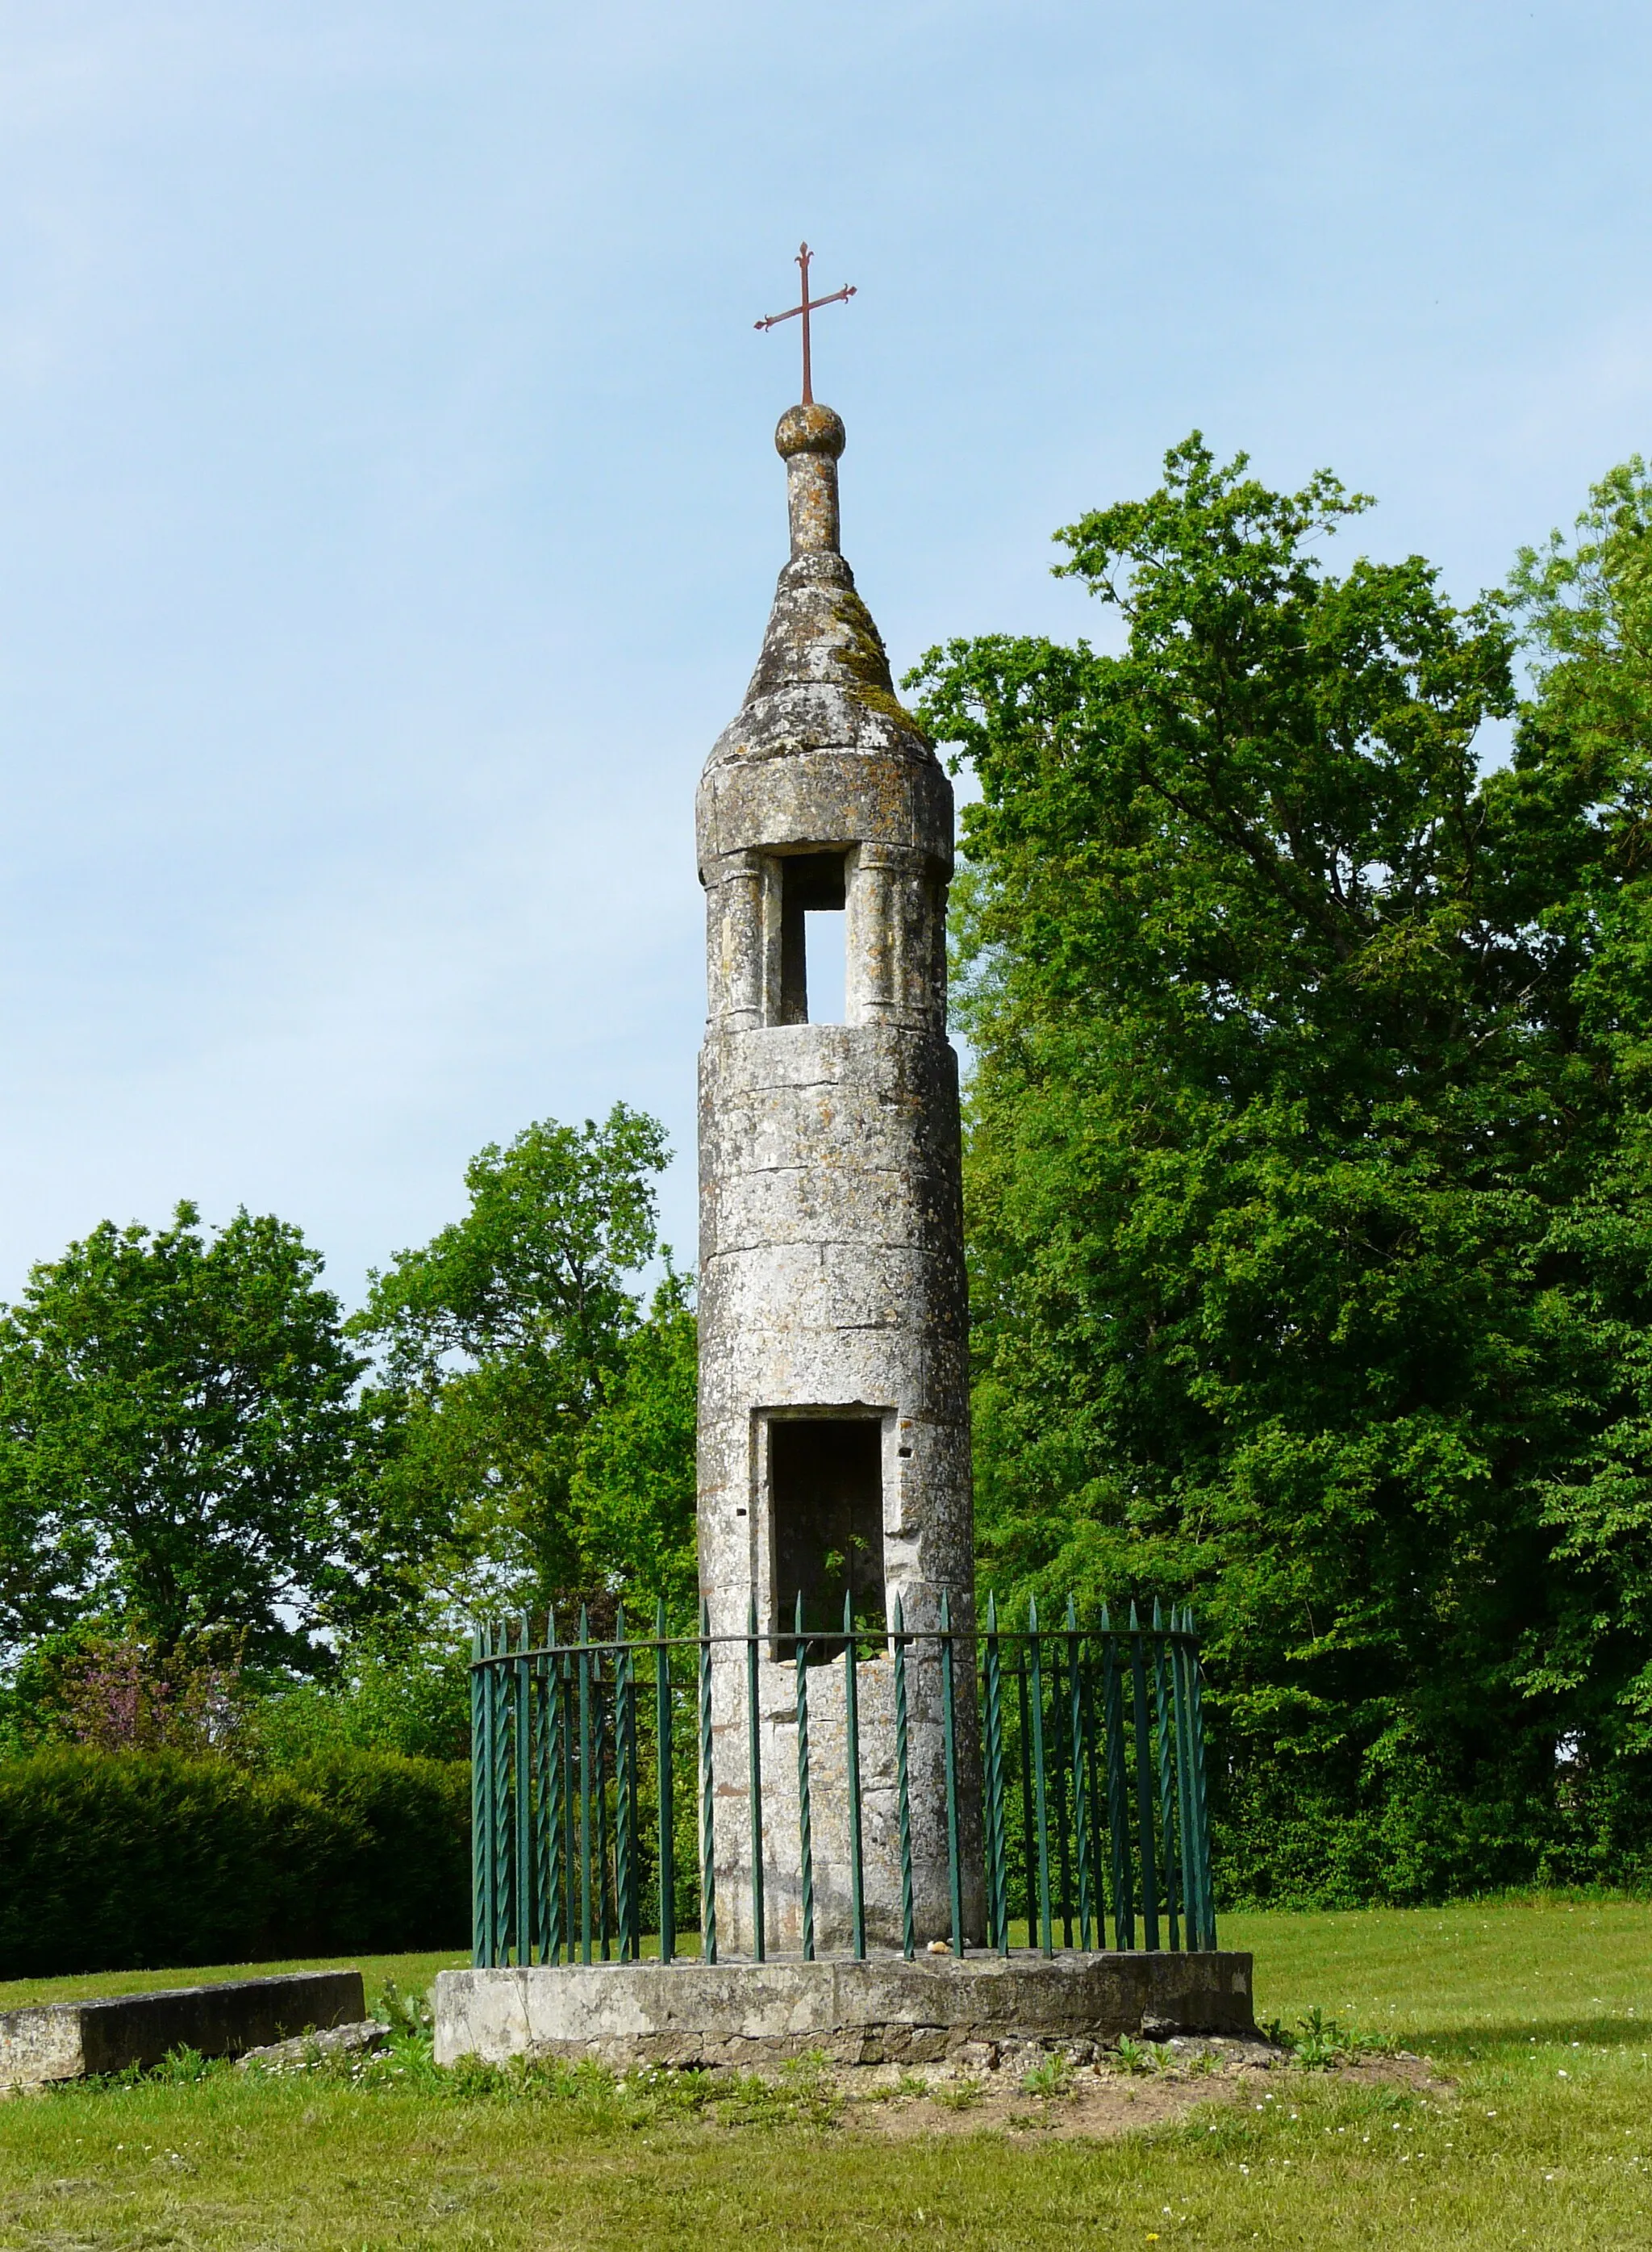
[470, 1601, 1216, 1966]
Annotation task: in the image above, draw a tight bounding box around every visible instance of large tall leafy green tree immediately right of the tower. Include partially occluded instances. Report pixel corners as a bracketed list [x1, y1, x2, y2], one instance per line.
[914, 435, 1652, 1899]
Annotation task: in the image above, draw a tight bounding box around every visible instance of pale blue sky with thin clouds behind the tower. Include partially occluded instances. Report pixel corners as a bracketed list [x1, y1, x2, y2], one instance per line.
[0, 0, 1652, 1299]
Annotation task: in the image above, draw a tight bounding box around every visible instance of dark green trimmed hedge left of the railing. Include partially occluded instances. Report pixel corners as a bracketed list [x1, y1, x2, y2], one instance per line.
[0, 1750, 470, 1977]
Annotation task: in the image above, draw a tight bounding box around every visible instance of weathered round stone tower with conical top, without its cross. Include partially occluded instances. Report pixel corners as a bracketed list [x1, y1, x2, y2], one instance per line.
[695, 403, 982, 1953]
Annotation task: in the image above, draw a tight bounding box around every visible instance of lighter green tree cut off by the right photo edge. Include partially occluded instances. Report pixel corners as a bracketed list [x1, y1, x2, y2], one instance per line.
[1492, 455, 1652, 1797]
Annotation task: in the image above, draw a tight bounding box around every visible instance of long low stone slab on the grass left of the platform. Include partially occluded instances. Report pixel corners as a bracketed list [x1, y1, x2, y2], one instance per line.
[0, 1970, 367, 2090]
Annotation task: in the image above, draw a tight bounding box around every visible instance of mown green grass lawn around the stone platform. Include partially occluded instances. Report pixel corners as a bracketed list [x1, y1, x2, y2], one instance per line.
[0, 1901, 1652, 2252]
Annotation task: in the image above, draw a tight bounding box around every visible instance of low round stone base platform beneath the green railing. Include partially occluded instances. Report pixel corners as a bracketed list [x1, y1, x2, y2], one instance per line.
[436, 1953, 1254, 2065]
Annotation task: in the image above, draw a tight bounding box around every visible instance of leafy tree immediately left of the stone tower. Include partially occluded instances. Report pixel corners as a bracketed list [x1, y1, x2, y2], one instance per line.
[351, 1104, 693, 1603]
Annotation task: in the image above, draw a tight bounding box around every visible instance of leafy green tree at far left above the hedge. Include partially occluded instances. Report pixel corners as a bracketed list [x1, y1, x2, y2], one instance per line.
[0, 1202, 371, 1671]
